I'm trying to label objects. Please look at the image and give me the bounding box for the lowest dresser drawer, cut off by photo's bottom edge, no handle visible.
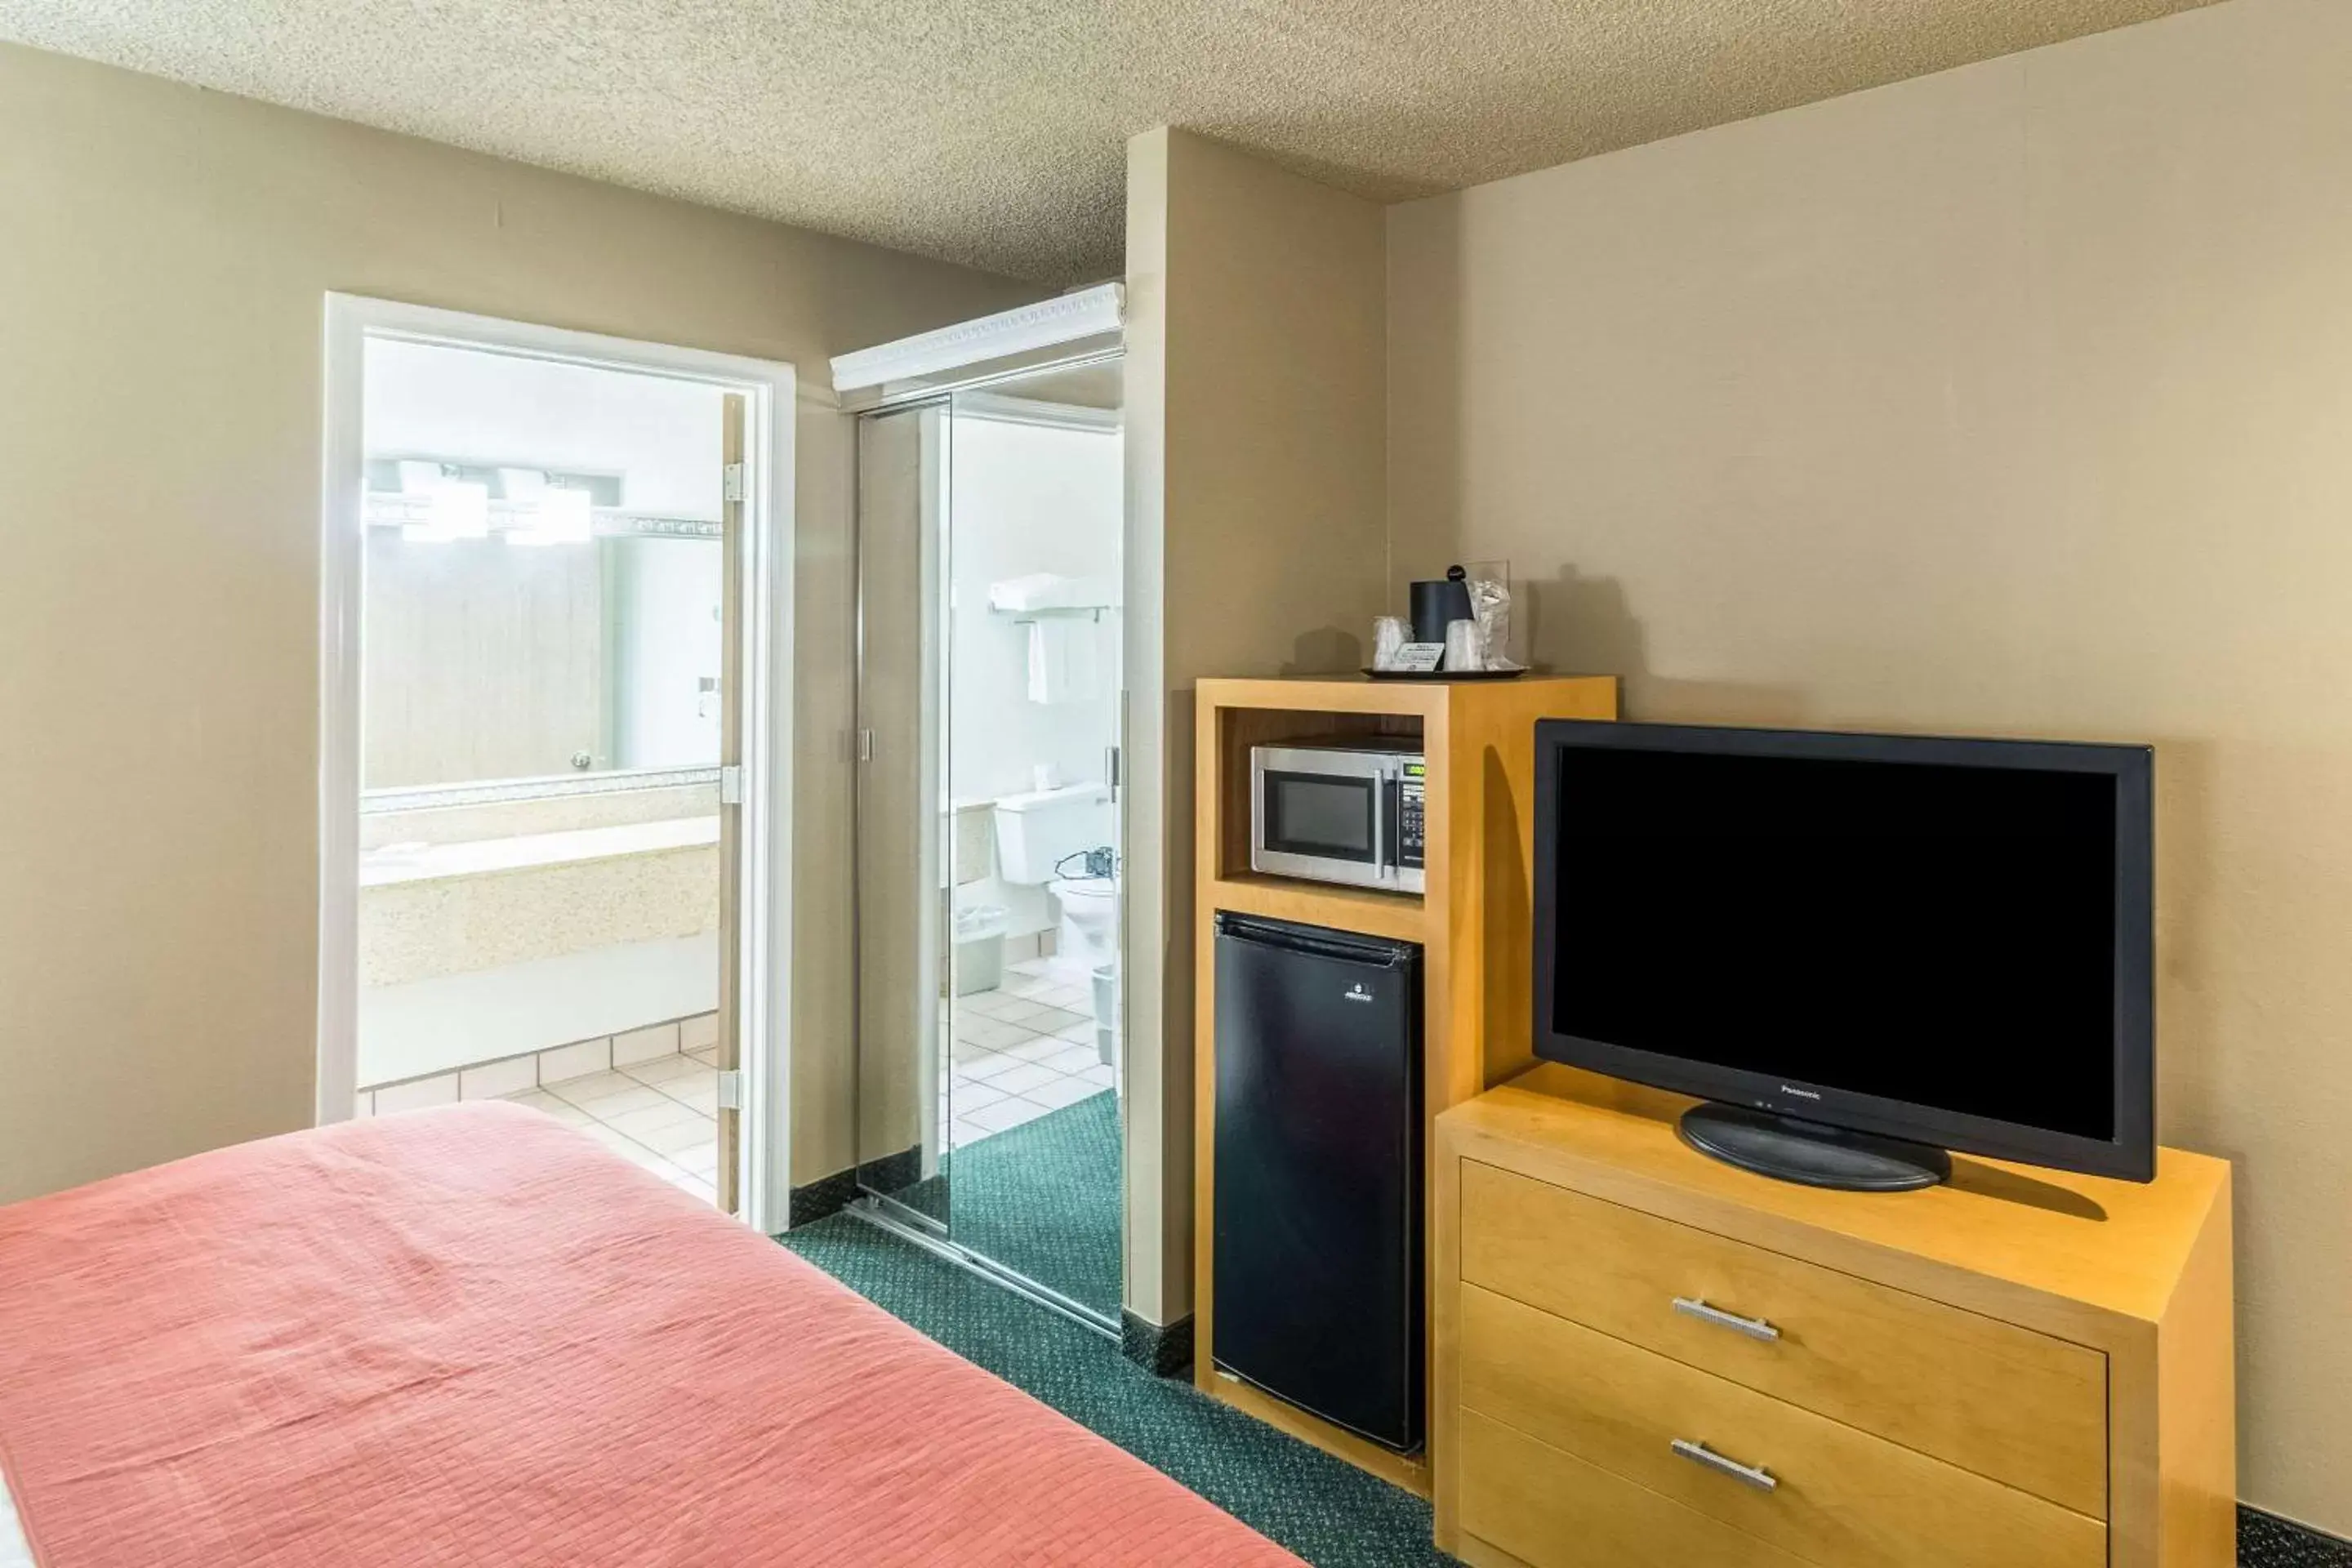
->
[1454,1410,1809,1568]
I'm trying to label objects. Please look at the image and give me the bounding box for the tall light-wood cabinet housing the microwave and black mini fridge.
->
[1192,675,1618,1498]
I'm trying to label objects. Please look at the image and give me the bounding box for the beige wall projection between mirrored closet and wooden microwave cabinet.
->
[1127,129,1385,1324]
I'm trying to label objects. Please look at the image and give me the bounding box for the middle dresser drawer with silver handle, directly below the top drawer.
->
[1459,1286,2107,1568]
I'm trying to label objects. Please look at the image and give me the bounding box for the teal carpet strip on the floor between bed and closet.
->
[781,1222,1454,1568]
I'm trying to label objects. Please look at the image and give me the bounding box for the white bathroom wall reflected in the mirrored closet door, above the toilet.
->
[948,412,1125,936]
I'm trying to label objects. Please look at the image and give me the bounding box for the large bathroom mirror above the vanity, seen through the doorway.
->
[360,328,724,797]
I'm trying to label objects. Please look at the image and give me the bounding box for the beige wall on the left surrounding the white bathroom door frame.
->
[0,47,1035,1199]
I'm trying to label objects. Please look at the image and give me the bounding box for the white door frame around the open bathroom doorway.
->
[318,294,795,1232]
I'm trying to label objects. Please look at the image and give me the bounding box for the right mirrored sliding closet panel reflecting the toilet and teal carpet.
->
[943,359,1125,1321]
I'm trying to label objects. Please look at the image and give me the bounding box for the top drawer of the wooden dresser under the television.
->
[1460,1159,2107,1519]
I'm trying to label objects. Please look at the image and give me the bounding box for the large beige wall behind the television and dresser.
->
[1390,0,2352,1530]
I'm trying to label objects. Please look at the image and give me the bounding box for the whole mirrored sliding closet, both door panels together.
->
[837,291,1125,1330]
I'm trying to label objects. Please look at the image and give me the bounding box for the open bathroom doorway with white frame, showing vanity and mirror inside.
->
[320,301,791,1227]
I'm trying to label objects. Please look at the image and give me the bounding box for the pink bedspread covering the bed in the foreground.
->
[0,1102,1298,1568]
